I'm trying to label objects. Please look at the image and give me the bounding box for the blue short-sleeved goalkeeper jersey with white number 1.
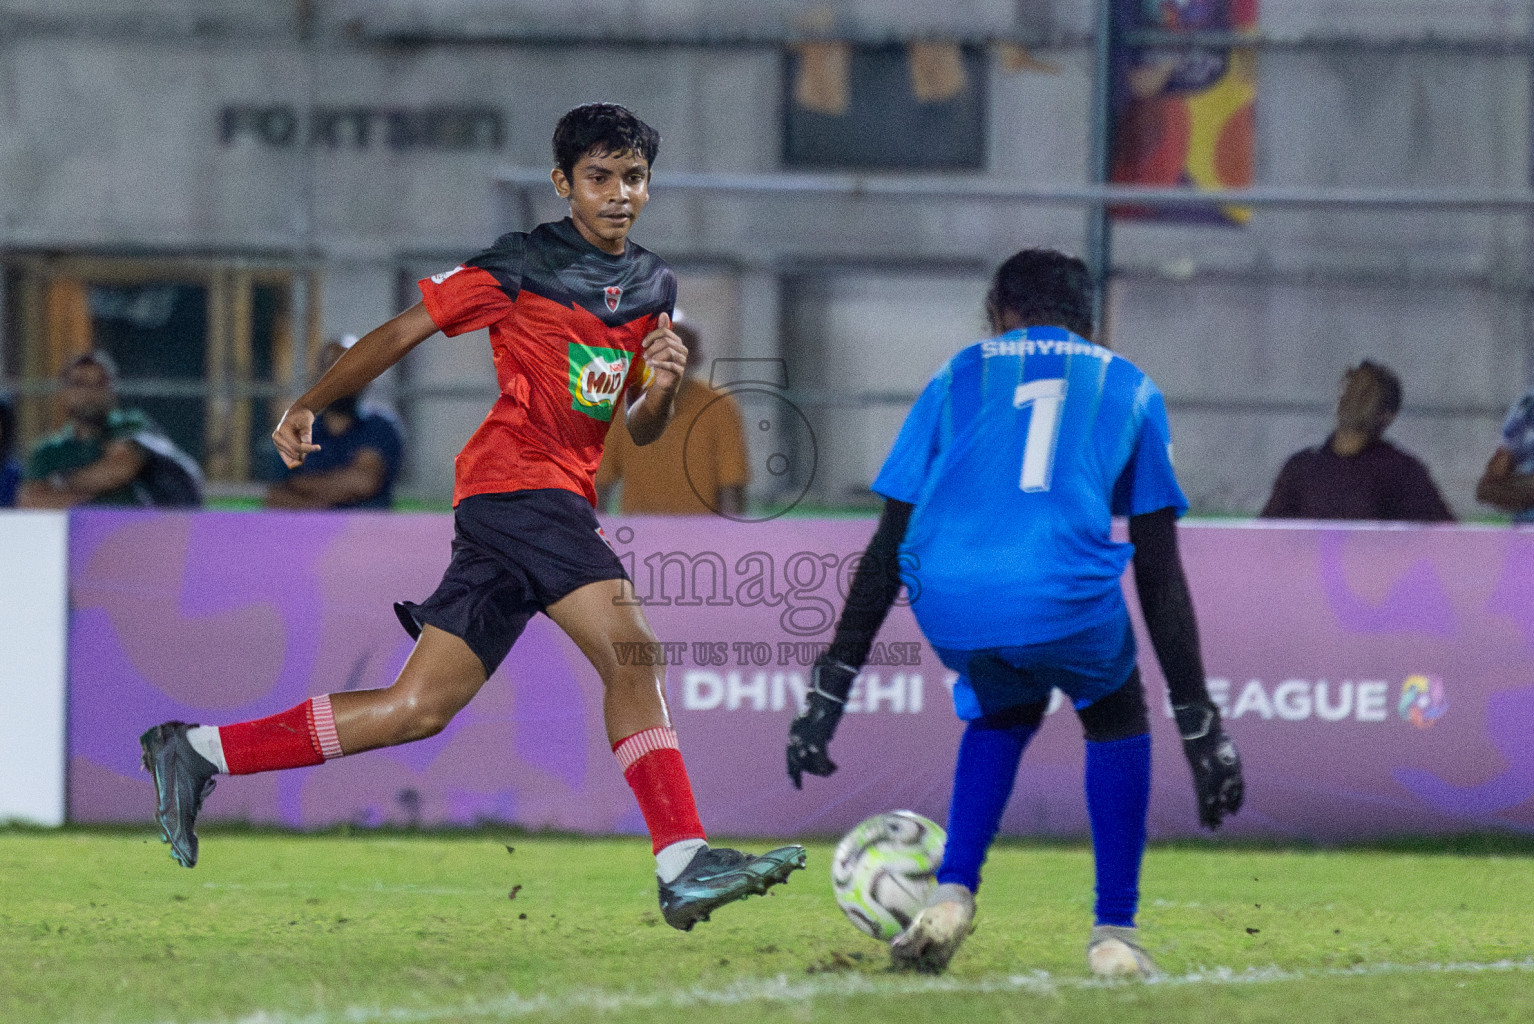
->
[873,327,1187,650]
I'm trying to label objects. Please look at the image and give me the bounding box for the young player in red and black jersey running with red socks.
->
[141,103,805,930]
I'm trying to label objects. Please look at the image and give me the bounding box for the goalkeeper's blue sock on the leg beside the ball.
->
[937,719,1035,892]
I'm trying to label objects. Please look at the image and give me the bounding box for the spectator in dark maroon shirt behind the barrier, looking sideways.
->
[1262,360,1454,523]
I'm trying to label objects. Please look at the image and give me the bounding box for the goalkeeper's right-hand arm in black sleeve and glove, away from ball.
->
[1129,509,1246,828]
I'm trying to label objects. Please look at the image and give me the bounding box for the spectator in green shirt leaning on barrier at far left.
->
[17,351,202,509]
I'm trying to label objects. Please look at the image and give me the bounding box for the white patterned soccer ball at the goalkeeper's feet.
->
[831,811,948,940]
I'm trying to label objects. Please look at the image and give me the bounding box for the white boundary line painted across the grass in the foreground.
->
[191,957,1534,1024]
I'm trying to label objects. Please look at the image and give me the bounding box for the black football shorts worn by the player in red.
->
[394,487,627,676]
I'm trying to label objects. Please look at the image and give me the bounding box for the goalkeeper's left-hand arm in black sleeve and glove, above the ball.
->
[788,498,913,789]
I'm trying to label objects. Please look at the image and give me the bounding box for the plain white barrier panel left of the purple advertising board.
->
[0,510,69,825]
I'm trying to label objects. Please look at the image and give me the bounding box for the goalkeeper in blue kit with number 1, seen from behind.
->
[788,250,1243,976]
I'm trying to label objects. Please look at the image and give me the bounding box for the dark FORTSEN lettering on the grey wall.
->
[218,103,506,152]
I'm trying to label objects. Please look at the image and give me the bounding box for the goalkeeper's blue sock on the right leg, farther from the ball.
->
[1086,733,1151,927]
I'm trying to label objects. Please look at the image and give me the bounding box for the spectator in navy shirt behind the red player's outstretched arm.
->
[265,334,405,509]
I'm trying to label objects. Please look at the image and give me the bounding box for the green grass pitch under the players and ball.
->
[0,828,1534,1024]
